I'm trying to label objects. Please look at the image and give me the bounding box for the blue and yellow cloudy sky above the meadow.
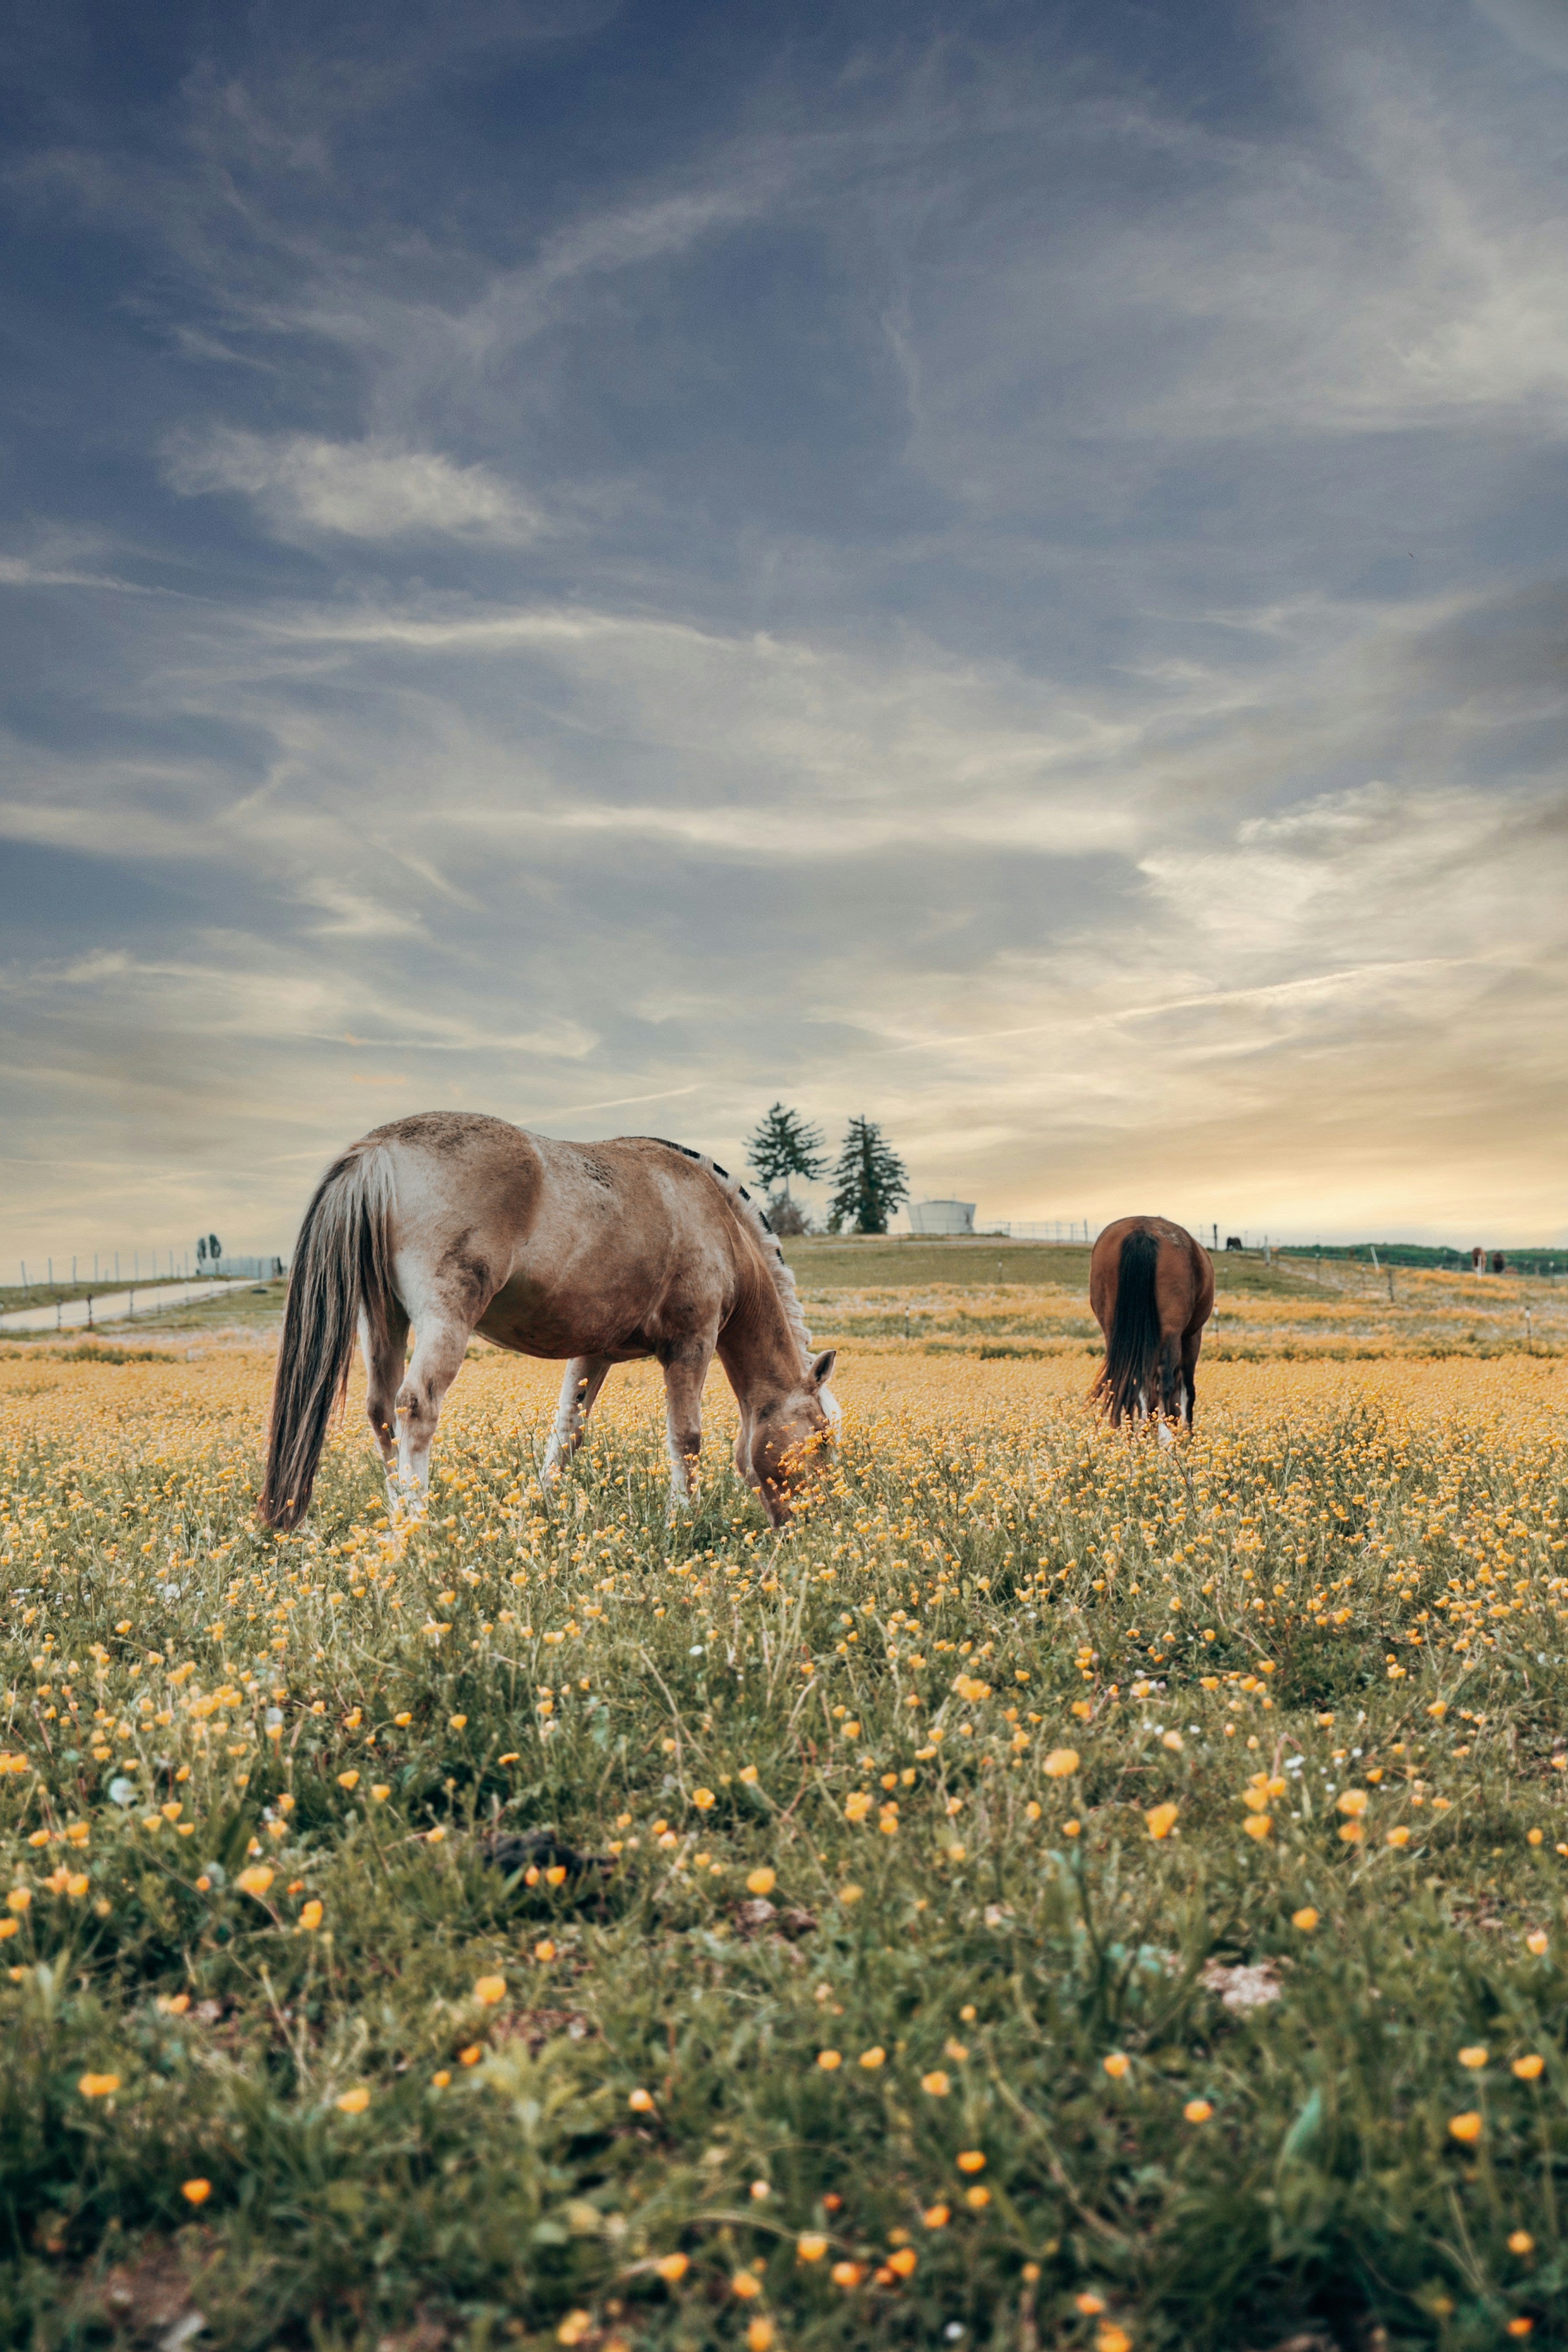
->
[0,0,1568,1280]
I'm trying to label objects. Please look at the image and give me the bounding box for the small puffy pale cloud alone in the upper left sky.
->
[164,426,543,546]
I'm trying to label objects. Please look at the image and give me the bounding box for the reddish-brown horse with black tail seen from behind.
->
[1088,1216,1213,1428]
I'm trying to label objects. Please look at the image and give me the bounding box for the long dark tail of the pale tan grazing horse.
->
[261,1146,393,1529]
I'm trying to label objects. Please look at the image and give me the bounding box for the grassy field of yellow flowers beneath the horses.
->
[0,1326,1568,2352]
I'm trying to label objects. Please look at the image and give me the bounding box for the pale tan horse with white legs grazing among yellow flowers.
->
[261,1110,839,1526]
